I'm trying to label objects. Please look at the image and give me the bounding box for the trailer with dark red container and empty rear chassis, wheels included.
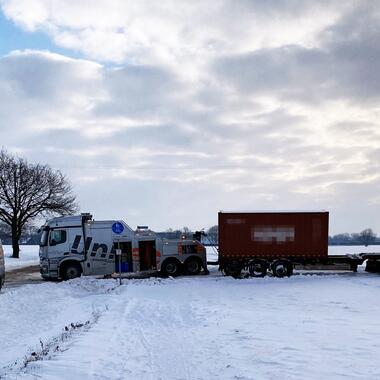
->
[218,211,380,277]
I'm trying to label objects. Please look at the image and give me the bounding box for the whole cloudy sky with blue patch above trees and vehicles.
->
[0,0,380,233]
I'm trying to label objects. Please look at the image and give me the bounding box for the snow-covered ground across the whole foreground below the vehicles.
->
[0,267,380,380]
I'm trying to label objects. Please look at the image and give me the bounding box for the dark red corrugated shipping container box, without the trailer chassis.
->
[219,211,329,258]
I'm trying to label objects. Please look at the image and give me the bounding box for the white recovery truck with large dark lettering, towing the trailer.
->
[40,214,208,280]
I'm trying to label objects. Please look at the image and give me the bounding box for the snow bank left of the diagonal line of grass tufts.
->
[0,278,116,379]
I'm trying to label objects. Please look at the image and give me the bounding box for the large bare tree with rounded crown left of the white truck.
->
[0,150,78,258]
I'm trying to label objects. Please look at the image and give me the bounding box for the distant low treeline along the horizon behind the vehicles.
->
[0,225,380,245]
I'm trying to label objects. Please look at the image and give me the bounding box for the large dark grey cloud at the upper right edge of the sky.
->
[214,2,380,102]
